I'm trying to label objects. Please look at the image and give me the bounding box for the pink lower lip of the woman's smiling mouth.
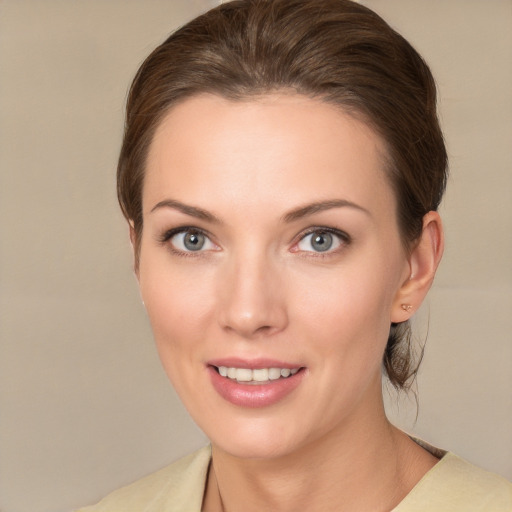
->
[208,366,304,408]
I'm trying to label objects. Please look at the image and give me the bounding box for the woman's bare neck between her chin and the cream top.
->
[205,384,437,512]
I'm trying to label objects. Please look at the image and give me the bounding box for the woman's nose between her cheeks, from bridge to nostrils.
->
[217,249,288,339]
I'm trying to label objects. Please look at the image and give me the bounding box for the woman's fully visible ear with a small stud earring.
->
[391,212,444,323]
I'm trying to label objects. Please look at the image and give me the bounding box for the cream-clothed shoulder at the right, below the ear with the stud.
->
[394,453,512,512]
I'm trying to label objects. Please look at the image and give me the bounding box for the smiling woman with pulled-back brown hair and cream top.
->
[78,0,512,512]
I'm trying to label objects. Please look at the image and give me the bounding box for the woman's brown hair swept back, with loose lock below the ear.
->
[117,0,447,389]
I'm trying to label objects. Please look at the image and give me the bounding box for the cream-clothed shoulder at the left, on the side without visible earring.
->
[77,446,211,512]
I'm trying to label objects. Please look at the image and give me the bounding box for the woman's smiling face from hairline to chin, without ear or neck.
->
[138,94,410,457]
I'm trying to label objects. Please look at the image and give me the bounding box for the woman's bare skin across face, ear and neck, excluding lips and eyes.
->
[132,93,443,511]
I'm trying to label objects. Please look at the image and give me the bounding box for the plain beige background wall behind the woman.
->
[0,0,512,512]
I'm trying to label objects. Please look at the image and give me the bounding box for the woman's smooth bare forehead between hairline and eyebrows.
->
[143,94,393,216]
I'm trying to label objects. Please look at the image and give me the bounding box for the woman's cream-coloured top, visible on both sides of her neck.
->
[78,442,512,512]
